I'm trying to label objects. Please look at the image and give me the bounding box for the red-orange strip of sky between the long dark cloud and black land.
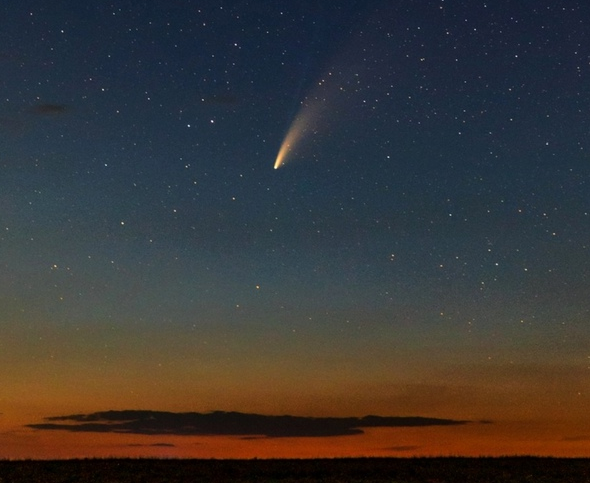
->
[0,422,590,459]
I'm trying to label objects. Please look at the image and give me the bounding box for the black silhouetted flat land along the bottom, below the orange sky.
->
[0,457,590,483]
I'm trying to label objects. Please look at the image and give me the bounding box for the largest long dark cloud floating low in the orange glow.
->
[27,410,467,437]
